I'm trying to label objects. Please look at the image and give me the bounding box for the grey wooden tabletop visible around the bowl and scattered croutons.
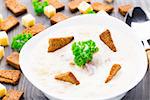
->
[0,0,150,100]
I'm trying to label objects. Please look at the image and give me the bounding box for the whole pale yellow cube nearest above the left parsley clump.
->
[22,14,35,27]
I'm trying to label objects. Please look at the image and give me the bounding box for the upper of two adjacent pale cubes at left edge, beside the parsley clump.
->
[0,31,9,46]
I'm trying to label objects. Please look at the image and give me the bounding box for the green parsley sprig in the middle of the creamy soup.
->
[72,40,99,68]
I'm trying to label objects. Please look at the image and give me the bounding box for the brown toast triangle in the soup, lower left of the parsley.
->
[55,72,80,85]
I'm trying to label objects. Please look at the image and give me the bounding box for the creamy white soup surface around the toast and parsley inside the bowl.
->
[25,26,143,100]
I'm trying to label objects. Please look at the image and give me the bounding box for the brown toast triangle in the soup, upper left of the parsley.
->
[48,36,74,52]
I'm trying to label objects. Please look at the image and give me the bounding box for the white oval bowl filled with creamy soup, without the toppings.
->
[20,14,147,100]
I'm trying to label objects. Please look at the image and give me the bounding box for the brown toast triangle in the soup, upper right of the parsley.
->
[99,29,117,52]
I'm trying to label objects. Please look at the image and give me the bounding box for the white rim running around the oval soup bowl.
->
[19,14,148,100]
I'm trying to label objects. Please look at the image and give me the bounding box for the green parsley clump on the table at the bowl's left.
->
[11,33,32,52]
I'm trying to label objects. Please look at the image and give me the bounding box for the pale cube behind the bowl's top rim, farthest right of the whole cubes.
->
[78,1,93,14]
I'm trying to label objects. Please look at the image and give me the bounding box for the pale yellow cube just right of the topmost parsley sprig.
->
[44,5,56,18]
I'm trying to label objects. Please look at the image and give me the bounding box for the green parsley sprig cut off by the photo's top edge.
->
[32,0,48,15]
